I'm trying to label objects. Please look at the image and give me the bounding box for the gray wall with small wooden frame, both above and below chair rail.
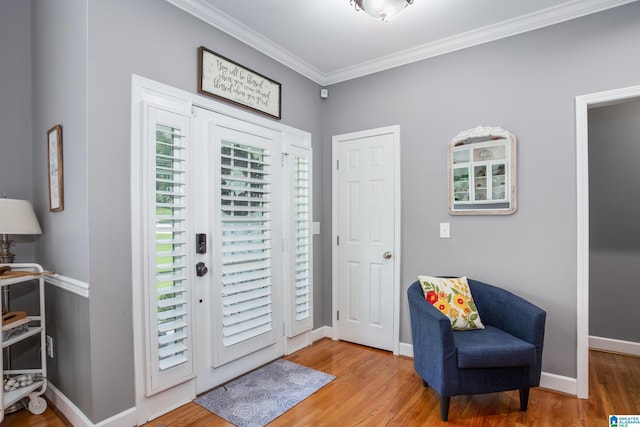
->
[30,0,94,418]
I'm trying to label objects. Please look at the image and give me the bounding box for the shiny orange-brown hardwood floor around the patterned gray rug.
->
[2,339,640,427]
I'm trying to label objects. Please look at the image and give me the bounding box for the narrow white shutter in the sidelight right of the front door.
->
[287,146,313,337]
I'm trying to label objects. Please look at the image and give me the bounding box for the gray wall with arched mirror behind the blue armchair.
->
[323,2,640,378]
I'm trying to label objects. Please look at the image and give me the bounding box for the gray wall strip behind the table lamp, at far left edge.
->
[0,0,35,262]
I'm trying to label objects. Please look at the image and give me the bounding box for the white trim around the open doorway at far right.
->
[576,86,640,399]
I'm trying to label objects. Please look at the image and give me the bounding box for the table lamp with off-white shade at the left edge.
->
[0,198,42,263]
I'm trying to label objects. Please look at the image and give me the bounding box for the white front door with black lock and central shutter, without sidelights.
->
[193,108,284,393]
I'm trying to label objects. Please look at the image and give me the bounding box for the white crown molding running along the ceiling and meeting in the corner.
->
[166,0,637,86]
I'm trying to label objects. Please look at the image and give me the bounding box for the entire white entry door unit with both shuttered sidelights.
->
[130,76,313,425]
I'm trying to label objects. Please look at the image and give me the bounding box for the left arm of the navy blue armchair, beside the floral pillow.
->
[407,281,458,397]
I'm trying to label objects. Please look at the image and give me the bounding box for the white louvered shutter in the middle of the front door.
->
[221,141,273,347]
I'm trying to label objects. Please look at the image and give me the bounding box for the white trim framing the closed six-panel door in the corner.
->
[331,125,401,355]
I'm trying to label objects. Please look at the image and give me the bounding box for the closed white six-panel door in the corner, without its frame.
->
[333,126,400,353]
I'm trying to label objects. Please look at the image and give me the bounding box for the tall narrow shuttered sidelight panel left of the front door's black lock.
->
[146,107,194,395]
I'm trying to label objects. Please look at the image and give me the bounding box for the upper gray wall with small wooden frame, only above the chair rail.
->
[31,0,89,282]
